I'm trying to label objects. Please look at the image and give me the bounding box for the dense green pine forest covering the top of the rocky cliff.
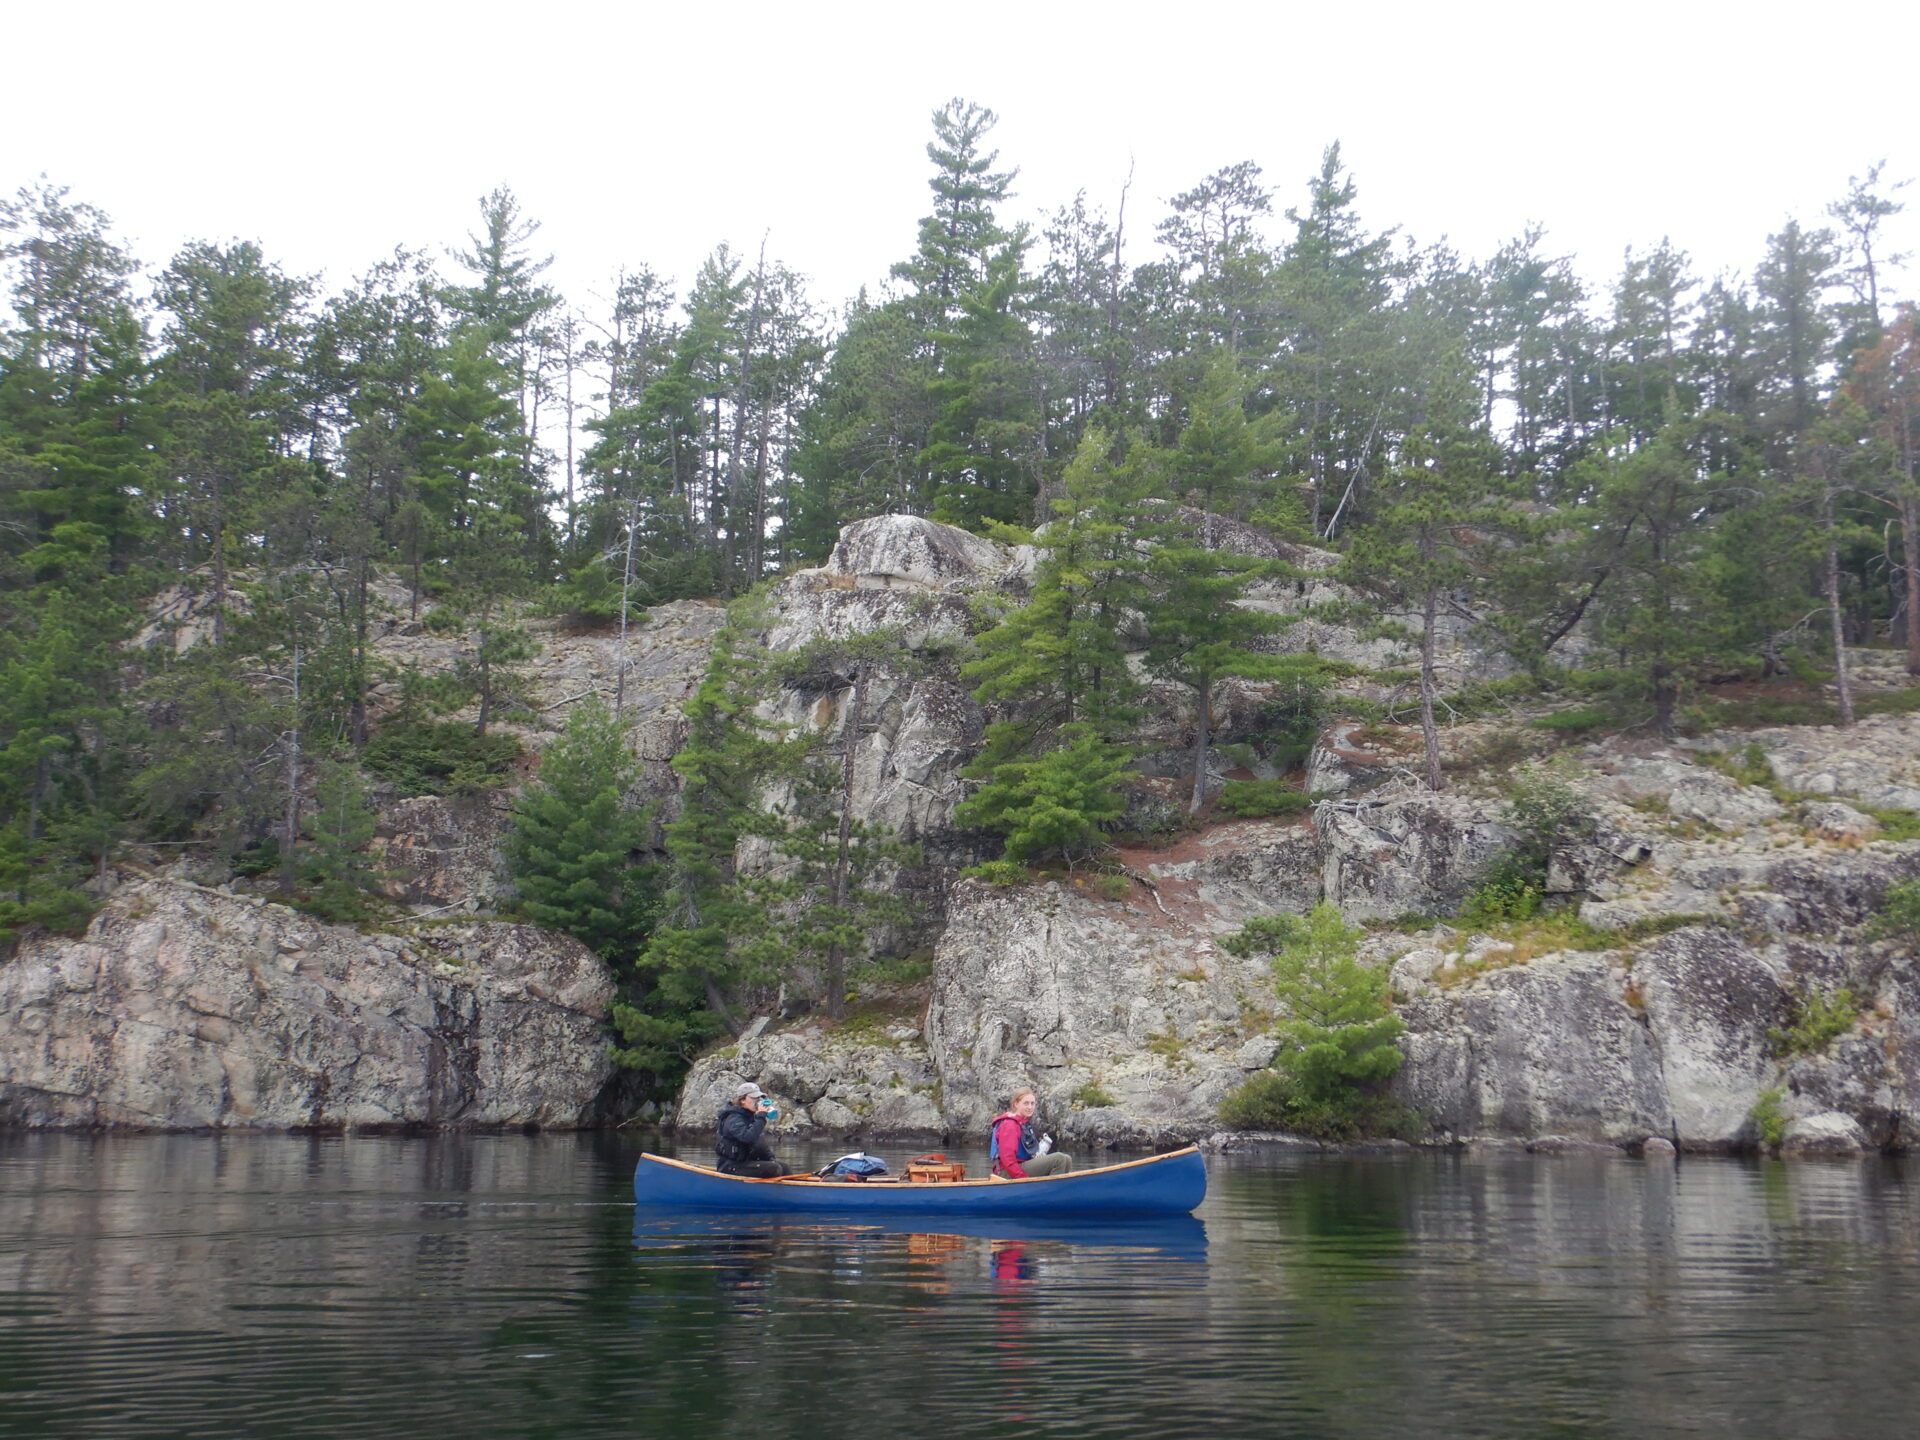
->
[0,100,1920,1052]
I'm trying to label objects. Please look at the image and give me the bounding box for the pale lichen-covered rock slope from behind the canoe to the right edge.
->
[682,537,1920,1152]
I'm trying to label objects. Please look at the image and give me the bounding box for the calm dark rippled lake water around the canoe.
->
[0,1135,1920,1440]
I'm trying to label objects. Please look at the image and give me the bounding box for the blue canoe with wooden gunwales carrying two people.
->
[634,1146,1206,1215]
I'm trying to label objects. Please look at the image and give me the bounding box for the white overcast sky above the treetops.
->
[0,0,1920,320]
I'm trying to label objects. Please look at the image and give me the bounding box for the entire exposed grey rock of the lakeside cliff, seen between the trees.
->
[15,516,1920,1152]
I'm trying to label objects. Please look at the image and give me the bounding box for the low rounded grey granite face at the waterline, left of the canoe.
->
[0,879,612,1129]
